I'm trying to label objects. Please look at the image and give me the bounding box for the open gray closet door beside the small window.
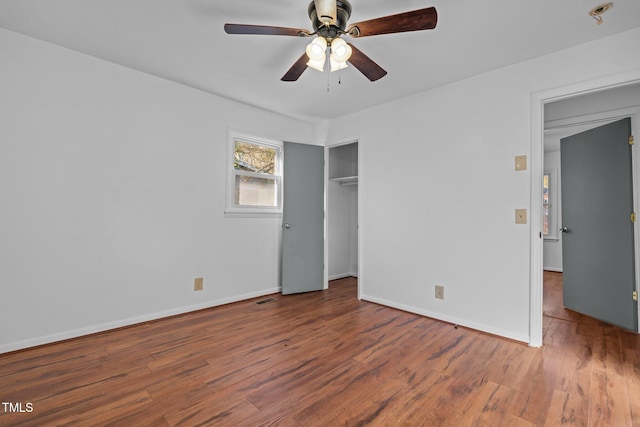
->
[282,142,324,295]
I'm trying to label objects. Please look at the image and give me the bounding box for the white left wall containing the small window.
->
[0,29,313,353]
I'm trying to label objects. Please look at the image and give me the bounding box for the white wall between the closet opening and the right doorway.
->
[328,29,640,342]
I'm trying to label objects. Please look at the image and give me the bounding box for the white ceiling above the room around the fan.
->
[0,0,640,121]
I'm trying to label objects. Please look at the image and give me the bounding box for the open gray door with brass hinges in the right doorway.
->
[560,119,638,331]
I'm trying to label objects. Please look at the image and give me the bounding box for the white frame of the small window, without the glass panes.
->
[225,130,284,217]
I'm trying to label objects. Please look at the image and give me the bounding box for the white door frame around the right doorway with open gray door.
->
[529,73,640,347]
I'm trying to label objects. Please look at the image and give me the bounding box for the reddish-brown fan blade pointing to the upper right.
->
[347,7,438,37]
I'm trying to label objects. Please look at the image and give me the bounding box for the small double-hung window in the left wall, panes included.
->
[226,132,282,215]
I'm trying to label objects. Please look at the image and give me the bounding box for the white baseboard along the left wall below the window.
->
[0,287,281,354]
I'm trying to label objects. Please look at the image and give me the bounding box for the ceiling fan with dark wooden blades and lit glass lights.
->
[224,0,438,82]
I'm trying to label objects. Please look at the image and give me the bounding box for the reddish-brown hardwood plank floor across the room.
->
[0,272,640,427]
